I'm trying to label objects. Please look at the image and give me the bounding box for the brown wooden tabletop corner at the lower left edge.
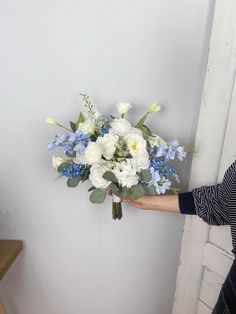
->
[0,240,23,280]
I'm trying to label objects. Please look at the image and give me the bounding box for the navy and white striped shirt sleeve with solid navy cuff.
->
[179,160,236,256]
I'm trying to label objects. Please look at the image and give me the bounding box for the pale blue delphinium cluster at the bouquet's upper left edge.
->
[48,130,90,155]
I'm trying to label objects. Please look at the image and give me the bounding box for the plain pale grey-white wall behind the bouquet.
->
[0,0,213,314]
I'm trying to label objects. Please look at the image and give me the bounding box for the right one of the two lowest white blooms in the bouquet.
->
[112,160,139,189]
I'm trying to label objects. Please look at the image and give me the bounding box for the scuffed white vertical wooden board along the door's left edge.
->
[172,0,236,314]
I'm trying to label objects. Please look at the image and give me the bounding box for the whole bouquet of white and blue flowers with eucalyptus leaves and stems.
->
[46,94,190,219]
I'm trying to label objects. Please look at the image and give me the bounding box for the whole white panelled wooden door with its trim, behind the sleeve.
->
[173,0,236,314]
